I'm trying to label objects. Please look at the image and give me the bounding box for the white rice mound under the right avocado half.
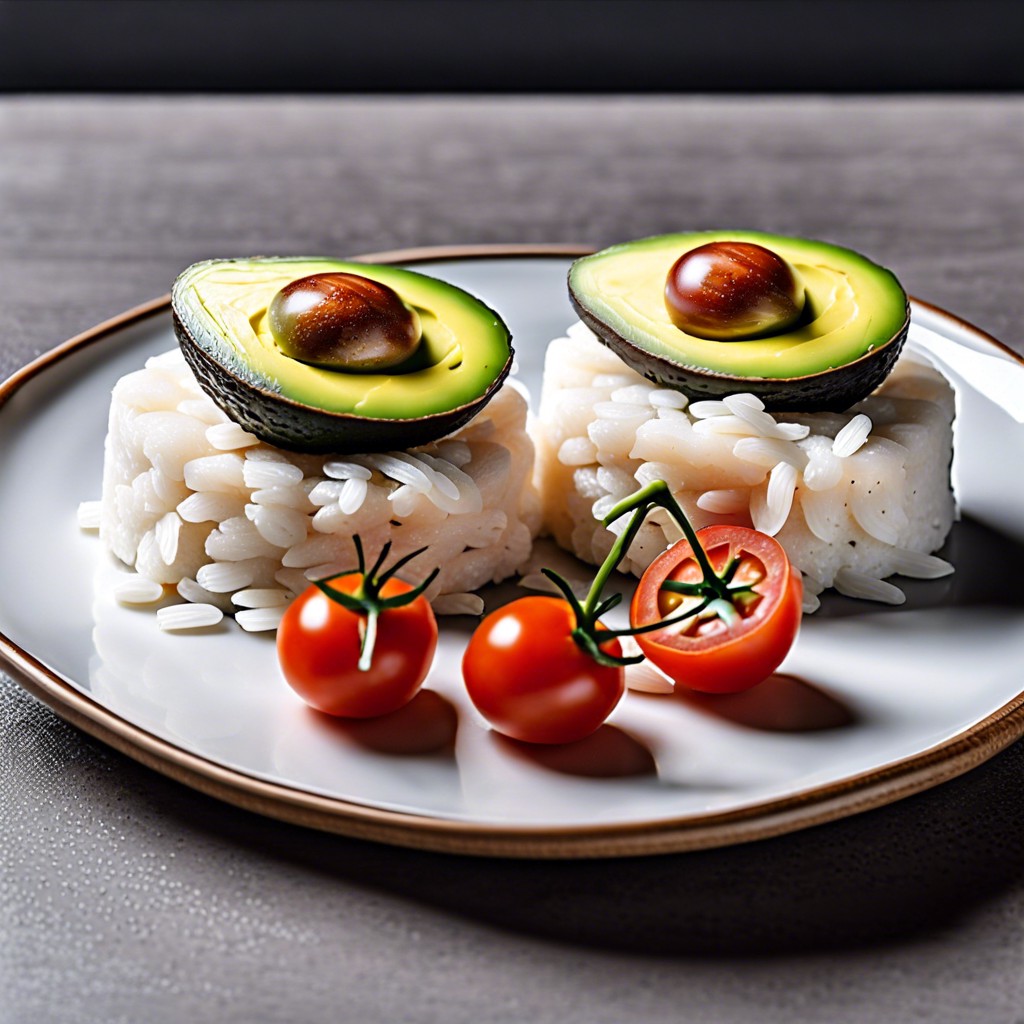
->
[535,324,955,610]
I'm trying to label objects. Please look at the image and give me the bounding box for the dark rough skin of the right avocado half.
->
[569,291,910,413]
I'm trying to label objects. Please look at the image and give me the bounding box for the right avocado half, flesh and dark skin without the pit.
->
[568,231,910,412]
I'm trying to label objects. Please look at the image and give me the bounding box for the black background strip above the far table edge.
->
[0,0,1024,93]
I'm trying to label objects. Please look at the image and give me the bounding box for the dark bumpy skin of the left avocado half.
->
[173,313,512,455]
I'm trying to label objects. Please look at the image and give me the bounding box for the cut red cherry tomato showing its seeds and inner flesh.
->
[630,526,803,693]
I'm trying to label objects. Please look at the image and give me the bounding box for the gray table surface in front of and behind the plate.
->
[0,96,1024,1024]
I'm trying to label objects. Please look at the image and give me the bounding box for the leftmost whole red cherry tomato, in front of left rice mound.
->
[278,572,437,718]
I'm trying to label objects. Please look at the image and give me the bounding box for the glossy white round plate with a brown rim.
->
[0,247,1024,856]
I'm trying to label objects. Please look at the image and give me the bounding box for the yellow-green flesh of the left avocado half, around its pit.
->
[172,258,511,420]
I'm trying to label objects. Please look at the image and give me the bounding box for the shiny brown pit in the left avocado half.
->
[267,273,423,373]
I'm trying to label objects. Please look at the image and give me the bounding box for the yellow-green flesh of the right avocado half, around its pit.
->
[569,231,907,380]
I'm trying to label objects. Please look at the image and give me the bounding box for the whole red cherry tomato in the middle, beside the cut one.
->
[462,597,626,743]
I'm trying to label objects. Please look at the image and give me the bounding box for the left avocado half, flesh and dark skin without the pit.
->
[171,257,512,455]
